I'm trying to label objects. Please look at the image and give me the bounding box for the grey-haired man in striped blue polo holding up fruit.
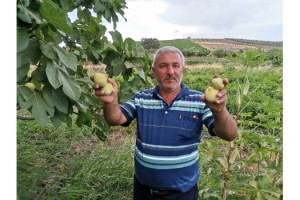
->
[91,46,237,200]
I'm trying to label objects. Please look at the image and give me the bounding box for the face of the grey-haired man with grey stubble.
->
[152,52,183,92]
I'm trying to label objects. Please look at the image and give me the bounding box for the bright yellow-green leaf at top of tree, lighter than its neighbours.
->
[40,0,72,33]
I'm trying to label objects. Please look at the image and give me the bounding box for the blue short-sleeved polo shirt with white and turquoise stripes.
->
[120,83,214,192]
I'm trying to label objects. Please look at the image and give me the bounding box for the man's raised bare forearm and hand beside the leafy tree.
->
[90,75,127,126]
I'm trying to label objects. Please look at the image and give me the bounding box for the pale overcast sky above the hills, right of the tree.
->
[103,0,283,41]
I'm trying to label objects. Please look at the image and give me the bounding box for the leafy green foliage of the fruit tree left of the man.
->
[17,0,152,138]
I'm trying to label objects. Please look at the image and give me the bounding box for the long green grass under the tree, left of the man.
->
[17,116,133,200]
